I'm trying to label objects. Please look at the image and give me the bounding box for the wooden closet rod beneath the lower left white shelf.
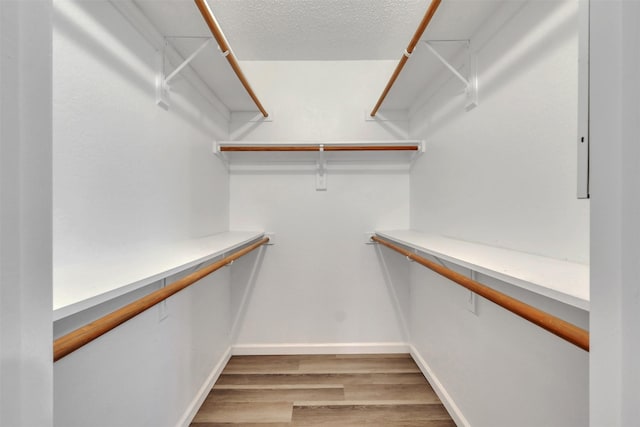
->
[53,237,269,362]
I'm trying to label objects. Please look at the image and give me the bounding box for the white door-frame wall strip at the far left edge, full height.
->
[0,1,53,427]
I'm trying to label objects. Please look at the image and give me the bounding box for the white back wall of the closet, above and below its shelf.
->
[230,61,409,351]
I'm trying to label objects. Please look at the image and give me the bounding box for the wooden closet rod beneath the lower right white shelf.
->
[371,236,589,351]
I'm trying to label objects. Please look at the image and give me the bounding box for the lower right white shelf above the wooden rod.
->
[376,230,589,311]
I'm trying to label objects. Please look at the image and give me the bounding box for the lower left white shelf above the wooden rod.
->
[53,231,264,321]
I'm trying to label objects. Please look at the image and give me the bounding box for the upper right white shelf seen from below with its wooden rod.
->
[372,0,524,115]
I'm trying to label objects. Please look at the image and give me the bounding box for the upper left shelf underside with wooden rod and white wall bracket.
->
[112,0,269,121]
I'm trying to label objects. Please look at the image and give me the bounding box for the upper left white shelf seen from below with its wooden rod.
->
[119,0,266,118]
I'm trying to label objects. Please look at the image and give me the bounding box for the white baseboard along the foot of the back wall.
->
[231,342,409,356]
